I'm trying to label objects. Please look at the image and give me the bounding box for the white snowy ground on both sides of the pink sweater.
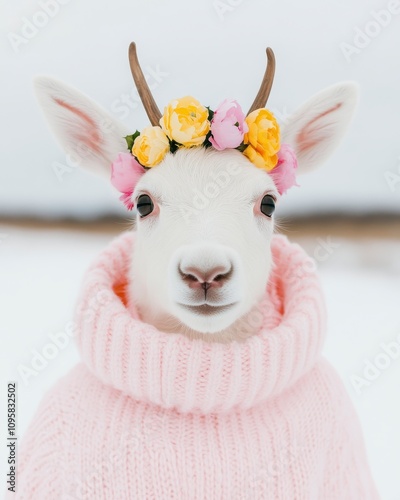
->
[0,225,400,500]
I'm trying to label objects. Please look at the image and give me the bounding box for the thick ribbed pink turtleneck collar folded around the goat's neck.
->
[77,233,325,413]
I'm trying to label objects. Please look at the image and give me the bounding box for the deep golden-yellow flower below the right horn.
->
[243,108,280,172]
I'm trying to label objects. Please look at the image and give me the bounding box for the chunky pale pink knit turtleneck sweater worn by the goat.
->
[10,234,378,500]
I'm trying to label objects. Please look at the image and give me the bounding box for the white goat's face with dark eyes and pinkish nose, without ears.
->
[131,148,279,333]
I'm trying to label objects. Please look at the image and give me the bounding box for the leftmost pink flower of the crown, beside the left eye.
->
[111,153,146,210]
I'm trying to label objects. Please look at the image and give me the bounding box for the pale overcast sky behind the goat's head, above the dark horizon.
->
[0,0,400,217]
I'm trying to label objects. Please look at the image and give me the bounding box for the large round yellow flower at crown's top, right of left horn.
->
[160,96,210,147]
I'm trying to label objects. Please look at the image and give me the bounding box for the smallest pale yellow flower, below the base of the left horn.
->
[132,126,170,167]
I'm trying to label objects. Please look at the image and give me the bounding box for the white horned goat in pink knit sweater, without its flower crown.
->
[9,45,378,500]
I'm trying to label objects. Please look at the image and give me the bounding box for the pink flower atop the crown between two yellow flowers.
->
[210,99,249,151]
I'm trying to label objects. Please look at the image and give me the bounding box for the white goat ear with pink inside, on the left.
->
[34,76,128,176]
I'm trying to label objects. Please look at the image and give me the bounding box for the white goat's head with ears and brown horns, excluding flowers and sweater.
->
[36,45,357,342]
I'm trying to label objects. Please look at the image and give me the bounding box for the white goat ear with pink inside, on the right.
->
[282,82,358,174]
